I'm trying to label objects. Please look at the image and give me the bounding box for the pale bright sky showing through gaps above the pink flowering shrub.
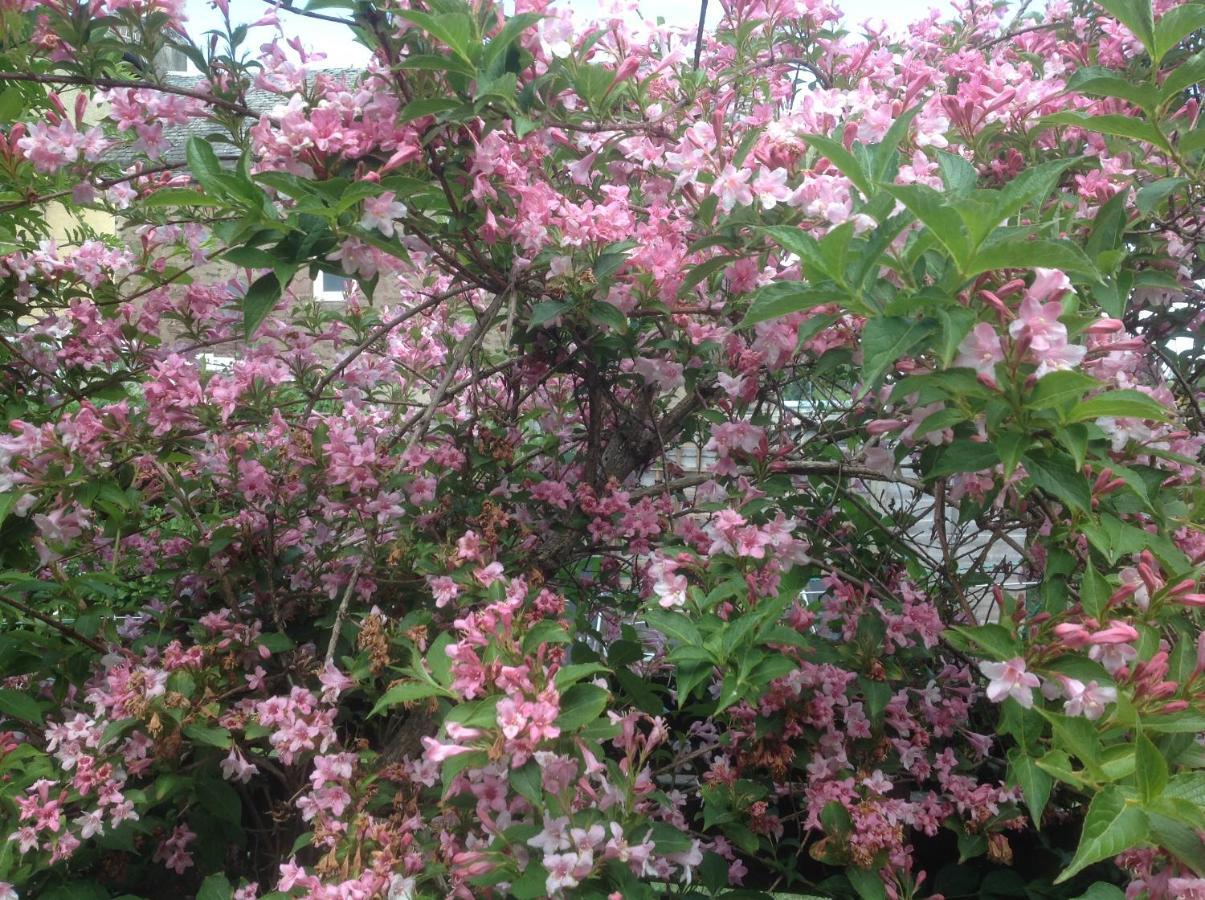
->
[186,0,948,66]
